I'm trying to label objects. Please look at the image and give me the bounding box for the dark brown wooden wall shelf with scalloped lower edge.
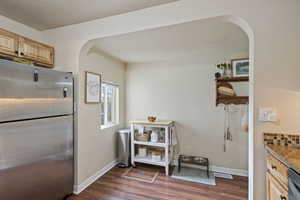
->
[216,77,249,105]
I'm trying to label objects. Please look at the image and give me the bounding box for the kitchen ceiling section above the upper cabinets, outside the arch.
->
[0,0,176,30]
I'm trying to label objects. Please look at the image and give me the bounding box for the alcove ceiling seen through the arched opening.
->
[93,20,249,63]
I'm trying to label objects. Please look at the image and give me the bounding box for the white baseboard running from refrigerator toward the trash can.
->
[73,161,118,194]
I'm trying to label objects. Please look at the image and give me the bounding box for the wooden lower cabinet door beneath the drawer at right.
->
[267,172,288,200]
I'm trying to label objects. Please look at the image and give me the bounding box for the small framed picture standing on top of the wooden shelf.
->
[231,58,249,77]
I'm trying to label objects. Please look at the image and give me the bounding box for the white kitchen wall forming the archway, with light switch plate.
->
[44,0,300,200]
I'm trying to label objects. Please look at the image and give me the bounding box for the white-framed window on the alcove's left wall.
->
[100,82,119,129]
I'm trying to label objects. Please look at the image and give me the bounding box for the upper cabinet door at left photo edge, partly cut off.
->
[0,29,18,56]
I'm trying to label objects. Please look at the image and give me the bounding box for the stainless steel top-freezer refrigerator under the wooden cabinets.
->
[0,60,74,200]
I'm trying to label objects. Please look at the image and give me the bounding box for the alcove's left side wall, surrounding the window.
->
[75,42,125,185]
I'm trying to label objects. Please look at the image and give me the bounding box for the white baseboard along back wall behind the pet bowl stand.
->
[174,161,248,177]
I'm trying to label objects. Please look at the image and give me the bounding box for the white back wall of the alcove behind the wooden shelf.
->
[126,59,249,171]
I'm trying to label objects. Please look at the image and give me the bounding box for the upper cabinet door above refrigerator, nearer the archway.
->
[20,37,54,66]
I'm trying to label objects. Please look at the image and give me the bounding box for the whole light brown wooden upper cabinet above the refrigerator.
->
[0,29,54,67]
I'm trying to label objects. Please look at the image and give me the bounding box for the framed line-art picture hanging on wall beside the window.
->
[85,72,101,103]
